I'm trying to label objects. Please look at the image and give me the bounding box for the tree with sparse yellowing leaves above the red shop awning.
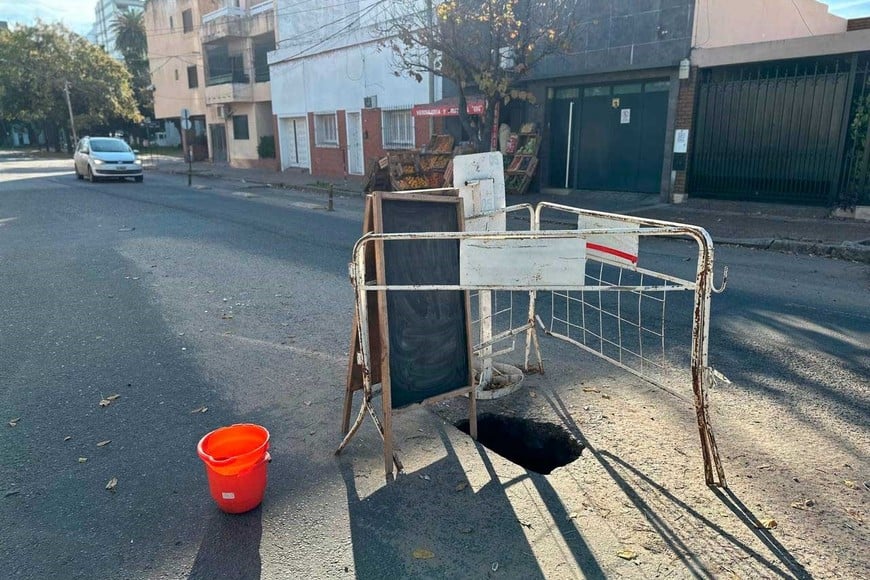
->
[380,0,578,151]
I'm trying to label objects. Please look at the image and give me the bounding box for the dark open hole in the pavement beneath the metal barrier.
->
[456,413,583,475]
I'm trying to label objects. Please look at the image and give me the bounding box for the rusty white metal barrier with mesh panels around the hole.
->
[339,203,725,486]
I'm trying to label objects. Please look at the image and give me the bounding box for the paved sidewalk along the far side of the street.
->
[145,156,870,264]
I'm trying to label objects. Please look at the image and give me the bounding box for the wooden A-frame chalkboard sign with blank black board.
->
[336,190,477,478]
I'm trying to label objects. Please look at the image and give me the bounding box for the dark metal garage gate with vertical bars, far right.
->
[689,53,870,206]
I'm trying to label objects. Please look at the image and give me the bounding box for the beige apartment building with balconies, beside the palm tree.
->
[146,0,275,167]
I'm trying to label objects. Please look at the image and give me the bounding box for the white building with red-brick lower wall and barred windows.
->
[269,0,441,176]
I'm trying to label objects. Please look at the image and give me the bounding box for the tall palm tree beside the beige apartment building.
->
[112,8,154,125]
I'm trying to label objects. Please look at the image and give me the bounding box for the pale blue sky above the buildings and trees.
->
[0,0,870,35]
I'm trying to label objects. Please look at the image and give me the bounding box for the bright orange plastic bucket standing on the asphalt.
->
[196,423,272,514]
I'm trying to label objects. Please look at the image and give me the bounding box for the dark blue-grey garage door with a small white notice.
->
[549,80,670,193]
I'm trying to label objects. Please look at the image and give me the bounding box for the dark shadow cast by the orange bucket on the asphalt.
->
[188,506,263,580]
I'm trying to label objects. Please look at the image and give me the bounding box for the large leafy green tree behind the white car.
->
[0,22,141,150]
